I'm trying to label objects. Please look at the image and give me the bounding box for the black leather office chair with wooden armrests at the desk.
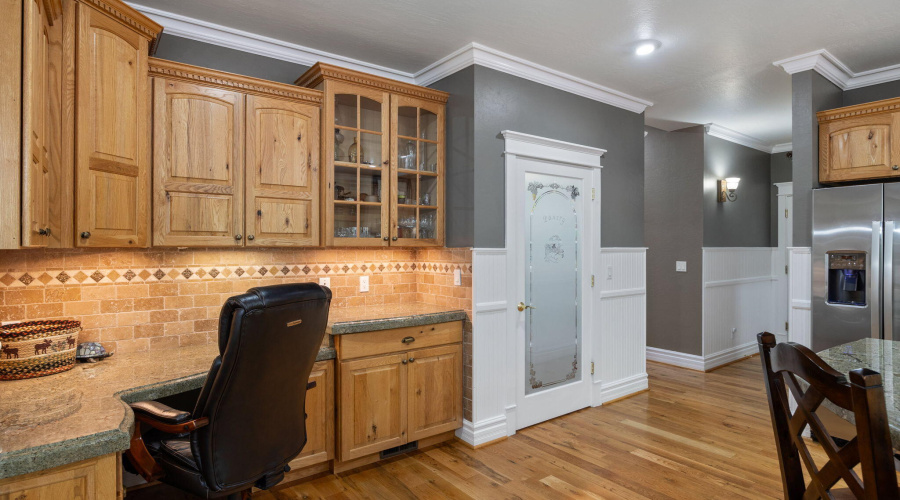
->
[126,283,331,498]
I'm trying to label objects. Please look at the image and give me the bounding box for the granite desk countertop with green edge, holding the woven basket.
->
[0,342,335,479]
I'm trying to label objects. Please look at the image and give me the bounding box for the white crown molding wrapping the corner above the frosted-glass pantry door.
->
[415,42,653,113]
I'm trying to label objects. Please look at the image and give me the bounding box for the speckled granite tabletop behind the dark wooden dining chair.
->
[817,339,900,449]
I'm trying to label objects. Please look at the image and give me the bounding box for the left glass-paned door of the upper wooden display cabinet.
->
[322,82,391,246]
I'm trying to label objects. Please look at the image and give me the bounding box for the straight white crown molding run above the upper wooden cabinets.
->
[128,3,414,83]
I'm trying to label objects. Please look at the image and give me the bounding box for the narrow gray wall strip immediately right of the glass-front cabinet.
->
[431,66,475,247]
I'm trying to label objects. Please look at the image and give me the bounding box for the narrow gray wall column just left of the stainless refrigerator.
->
[791,70,843,247]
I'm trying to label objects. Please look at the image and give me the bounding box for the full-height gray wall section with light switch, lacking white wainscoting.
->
[644,126,705,355]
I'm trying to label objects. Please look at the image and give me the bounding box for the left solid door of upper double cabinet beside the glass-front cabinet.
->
[153,78,244,246]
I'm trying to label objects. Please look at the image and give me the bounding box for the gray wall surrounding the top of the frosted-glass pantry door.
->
[474,66,644,248]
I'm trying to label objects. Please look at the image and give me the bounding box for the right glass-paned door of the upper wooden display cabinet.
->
[390,95,444,246]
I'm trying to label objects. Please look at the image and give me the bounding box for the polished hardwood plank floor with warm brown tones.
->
[254,357,800,500]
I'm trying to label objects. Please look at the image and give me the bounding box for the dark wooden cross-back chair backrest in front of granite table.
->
[757,332,900,500]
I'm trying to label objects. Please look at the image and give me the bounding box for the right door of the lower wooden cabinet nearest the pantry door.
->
[408,344,463,441]
